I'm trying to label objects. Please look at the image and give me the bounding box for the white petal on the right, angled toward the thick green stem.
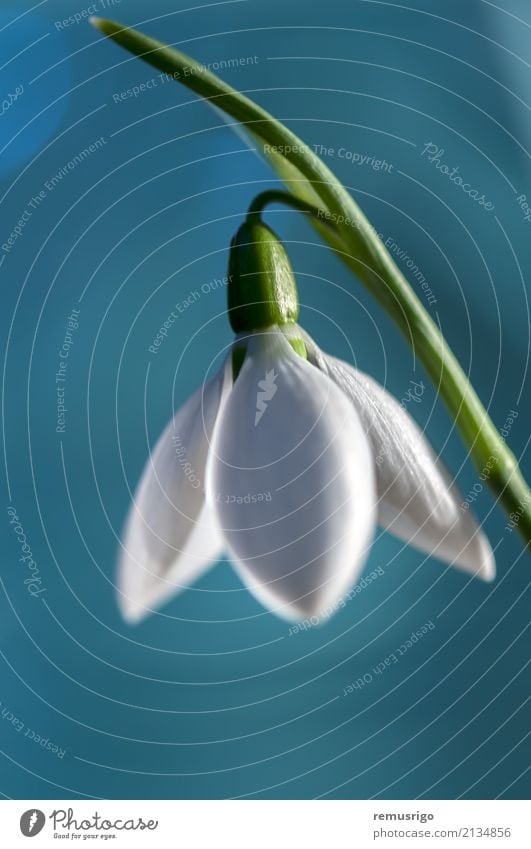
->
[305,336,495,581]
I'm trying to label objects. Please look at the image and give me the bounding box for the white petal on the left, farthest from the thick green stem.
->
[118,358,230,622]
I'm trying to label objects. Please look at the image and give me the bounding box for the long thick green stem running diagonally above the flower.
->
[92,18,531,544]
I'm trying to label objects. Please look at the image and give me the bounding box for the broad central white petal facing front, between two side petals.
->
[207,328,376,619]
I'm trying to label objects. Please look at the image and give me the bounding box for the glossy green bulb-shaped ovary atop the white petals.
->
[227,216,299,333]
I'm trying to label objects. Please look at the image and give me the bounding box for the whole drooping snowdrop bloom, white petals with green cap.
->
[118,221,495,621]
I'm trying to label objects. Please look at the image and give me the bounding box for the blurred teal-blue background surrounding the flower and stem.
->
[0,0,531,799]
